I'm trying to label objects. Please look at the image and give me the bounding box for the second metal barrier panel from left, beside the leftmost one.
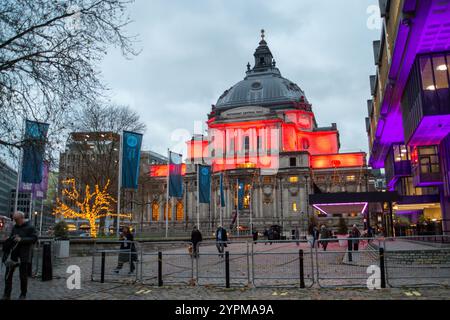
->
[139,242,194,286]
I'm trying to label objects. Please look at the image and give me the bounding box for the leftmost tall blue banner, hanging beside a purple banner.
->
[22,120,49,183]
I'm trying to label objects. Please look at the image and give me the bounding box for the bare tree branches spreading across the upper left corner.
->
[0,0,137,165]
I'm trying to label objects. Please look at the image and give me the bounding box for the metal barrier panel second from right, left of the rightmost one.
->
[315,238,380,288]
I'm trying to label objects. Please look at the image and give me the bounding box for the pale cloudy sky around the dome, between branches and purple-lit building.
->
[101,0,380,158]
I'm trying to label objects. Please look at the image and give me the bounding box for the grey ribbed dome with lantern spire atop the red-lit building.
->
[215,33,307,109]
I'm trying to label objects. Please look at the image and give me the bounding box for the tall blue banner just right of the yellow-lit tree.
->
[122,131,142,189]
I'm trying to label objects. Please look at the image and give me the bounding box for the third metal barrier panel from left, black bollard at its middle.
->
[196,241,250,288]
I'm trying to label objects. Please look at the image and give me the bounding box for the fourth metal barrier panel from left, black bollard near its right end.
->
[251,240,314,288]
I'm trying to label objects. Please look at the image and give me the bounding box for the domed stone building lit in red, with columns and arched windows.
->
[142,32,369,238]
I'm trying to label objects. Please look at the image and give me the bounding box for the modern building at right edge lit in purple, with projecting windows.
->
[366,0,450,235]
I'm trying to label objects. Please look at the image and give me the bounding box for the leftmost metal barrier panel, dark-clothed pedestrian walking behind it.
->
[91,241,140,283]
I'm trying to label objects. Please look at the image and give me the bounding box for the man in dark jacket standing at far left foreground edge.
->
[2,211,38,300]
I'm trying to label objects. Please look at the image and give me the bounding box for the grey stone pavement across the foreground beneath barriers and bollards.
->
[0,243,450,300]
